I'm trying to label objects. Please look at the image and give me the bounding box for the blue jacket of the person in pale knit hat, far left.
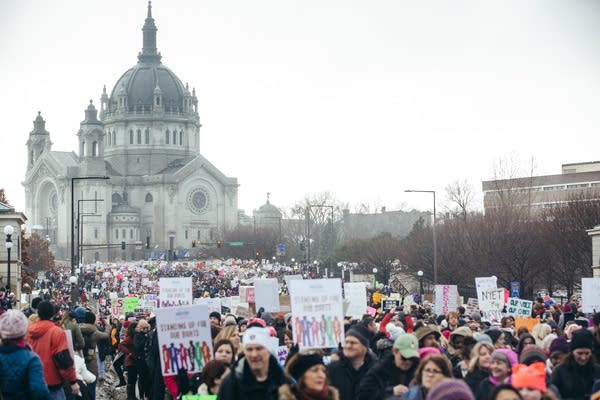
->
[0,342,50,400]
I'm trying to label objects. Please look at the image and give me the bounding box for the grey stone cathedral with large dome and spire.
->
[23,3,238,263]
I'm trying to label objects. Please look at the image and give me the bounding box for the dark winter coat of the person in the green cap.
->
[356,354,418,400]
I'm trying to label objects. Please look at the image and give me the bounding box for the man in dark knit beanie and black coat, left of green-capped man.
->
[327,325,377,400]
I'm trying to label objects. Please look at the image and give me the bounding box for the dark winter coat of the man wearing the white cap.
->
[218,355,290,400]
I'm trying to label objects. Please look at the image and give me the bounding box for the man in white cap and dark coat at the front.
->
[218,326,288,400]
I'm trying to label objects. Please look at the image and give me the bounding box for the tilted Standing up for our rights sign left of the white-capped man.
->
[155,304,213,376]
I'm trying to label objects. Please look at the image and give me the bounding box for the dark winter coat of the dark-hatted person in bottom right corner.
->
[551,356,600,400]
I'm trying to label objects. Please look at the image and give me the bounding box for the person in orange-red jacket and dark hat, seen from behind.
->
[26,301,80,400]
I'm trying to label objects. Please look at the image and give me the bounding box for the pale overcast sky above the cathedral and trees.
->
[0,0,600,219]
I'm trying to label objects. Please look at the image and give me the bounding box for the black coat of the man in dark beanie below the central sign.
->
[327,352,377,400]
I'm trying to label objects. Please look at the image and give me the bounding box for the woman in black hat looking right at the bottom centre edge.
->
[279,352,339,400]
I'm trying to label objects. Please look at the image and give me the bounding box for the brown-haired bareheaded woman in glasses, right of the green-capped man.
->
[401,354,452,400]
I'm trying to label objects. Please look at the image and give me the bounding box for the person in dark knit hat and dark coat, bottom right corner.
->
[551,329,600,399]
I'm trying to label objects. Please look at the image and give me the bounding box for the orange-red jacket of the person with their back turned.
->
[25,321,77,386]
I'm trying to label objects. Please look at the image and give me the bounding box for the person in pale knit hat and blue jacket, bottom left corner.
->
[0,310,50,400]
